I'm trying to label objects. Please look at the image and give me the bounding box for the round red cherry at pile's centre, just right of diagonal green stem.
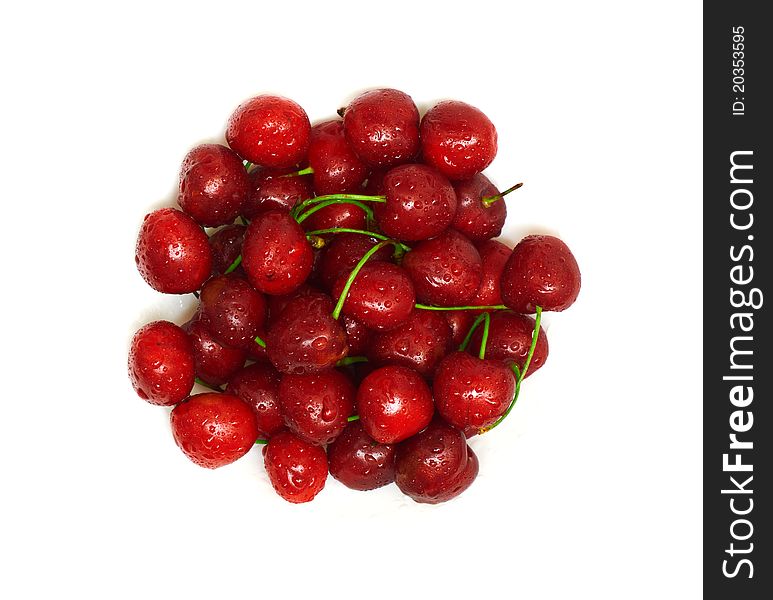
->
[333,261,416,331]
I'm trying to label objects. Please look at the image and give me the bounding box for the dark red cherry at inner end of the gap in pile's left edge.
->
[199,275,266,350]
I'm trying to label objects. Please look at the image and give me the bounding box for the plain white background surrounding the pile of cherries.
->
[0,0,702,600]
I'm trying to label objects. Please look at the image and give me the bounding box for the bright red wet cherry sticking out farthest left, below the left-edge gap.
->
[129,321,194,406]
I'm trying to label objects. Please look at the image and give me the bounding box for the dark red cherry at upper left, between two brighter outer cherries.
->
[177,144,247,227]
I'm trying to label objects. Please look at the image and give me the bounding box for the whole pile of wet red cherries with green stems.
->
[129,89,580,503]
